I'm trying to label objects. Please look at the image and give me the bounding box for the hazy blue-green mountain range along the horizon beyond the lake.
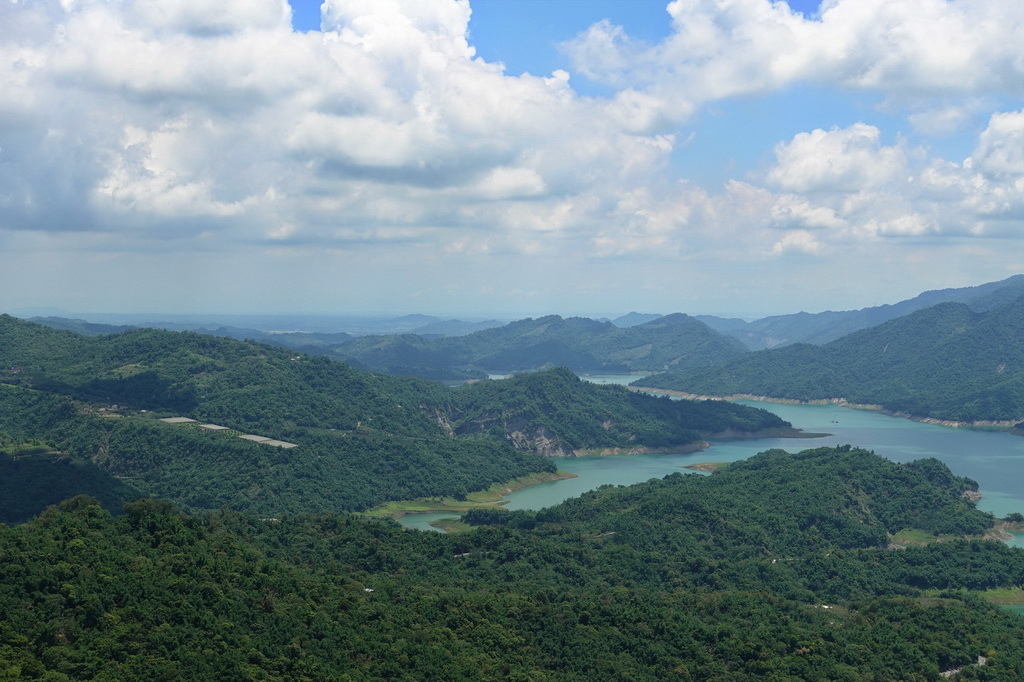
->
[18,274,1024,423]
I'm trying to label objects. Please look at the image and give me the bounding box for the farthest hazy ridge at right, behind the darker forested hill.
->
[700,274,1024,350]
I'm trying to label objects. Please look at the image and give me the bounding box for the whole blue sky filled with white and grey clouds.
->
[0,0,1024,316]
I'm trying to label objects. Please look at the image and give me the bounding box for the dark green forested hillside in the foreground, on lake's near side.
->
[0,447,1024,681]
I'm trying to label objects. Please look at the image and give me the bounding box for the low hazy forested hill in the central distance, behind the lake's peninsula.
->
[334,313,745,376]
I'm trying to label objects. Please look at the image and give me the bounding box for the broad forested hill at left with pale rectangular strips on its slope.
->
[0,315,782,520]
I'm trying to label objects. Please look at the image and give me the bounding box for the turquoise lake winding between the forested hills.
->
[401,399,1024,532]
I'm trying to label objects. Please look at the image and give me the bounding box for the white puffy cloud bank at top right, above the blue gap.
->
[565,0,1024,107]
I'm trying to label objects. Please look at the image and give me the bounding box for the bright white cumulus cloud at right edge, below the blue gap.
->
[764,112,1024,246]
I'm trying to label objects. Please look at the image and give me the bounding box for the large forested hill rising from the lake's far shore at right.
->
[636,297,1024,422]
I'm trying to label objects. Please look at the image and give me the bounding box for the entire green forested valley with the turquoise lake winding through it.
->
[0,274,1024,680]
